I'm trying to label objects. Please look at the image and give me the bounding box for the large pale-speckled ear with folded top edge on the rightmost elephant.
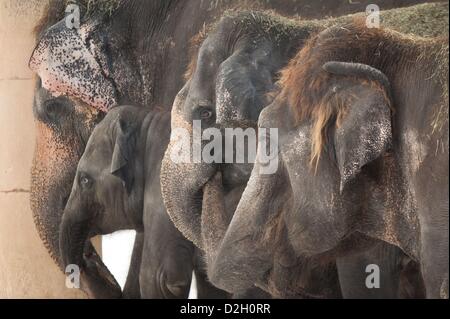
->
[324,62,392,192]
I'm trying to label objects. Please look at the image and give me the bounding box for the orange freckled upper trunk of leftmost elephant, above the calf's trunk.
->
[31,122,81,266]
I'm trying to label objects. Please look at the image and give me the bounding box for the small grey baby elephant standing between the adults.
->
[59,106,226,298]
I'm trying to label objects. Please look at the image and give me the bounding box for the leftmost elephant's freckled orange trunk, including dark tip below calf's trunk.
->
[30,114,120,298]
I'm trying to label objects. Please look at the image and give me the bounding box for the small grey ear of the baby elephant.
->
[111,118,137,194]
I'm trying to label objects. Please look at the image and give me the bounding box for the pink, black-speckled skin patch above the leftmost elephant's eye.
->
[29,20,117,112]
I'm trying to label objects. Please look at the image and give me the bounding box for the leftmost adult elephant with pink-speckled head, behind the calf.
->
[30,0,326,297]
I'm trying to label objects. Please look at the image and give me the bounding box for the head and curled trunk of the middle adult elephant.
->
[161,12,306,252]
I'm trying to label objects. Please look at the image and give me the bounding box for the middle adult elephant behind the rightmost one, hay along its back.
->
[162,4,448,296]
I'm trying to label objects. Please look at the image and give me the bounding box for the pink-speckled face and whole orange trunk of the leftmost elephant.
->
[29,11,124,297]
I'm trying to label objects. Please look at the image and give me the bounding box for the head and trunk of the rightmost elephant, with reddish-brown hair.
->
[210,27,424,291]
